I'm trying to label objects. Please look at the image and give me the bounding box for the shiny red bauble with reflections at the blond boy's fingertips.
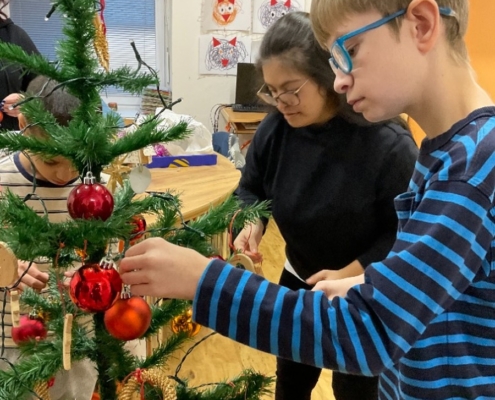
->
[69,264,122,312]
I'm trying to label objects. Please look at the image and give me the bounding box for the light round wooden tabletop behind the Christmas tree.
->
[147,154,241,221]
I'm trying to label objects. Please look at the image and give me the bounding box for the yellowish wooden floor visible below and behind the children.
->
[163,222,334,400]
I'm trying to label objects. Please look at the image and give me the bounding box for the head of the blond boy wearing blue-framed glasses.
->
[311,0,473,124]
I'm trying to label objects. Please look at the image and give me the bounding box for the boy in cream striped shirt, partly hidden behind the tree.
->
[0,76,96,400]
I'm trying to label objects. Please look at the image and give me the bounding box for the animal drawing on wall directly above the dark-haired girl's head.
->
[253,0,304,33]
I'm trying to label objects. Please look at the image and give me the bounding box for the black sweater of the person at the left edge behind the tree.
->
[0,19,39,130]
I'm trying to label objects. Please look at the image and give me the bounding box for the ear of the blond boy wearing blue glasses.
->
[406,0,441,53]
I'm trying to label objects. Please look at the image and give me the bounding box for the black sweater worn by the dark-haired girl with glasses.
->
[239,112,418,279]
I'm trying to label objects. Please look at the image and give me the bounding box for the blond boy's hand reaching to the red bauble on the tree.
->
[119,238,210,300]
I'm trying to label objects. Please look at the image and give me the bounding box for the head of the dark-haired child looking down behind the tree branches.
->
[19,76,79,186]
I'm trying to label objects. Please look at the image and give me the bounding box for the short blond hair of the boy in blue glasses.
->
[310,0,469,61]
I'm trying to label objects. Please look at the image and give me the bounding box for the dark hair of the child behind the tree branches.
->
[25,76,80,126]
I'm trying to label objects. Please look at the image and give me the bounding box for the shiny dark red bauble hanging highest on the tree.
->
[67,172,113,221]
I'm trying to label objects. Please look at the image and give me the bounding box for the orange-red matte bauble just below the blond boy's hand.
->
[104,297,151,340]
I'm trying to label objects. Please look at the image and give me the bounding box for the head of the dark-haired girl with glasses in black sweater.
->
[257,12,372,126]
